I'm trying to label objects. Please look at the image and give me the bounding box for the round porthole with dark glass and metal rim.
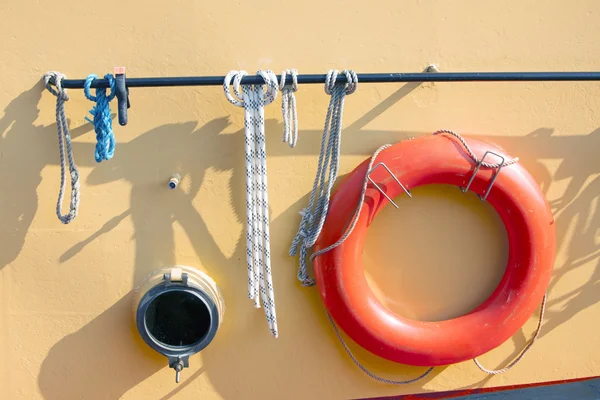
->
[133,266,225,383]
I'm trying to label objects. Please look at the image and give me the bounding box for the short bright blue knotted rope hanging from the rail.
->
[83,74,115,162]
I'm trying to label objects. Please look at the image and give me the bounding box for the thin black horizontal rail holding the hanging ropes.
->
[57,72,600,89]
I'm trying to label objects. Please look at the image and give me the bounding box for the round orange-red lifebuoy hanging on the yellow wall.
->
[313,135,556,366]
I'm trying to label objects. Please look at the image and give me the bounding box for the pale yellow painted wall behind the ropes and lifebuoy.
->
[0,0,600,400]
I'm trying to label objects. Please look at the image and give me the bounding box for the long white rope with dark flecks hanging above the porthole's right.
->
[223,71,278,338]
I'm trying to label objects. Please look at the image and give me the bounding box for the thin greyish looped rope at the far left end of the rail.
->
[44,71,79,224]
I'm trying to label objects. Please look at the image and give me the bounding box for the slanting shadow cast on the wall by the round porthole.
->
[38,292,164,400]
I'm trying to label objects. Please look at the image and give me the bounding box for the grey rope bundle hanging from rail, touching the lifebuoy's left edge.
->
[289,70,358,286]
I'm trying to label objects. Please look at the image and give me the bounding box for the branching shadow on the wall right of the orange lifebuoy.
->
[480,128,600,337]
